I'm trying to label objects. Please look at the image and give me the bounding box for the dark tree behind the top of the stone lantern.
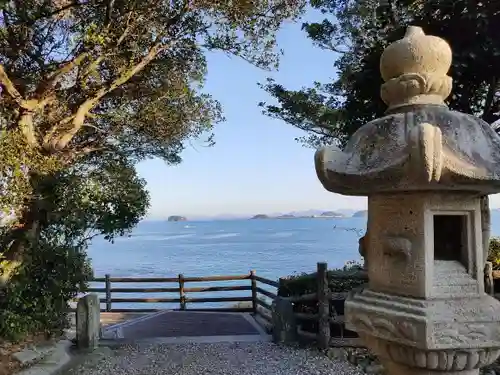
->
[261,0,500,147]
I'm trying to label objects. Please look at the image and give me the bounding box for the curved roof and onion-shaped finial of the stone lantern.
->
[315,29,500,195]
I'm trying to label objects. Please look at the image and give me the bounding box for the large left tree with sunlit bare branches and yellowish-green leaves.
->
[0,0,303,270]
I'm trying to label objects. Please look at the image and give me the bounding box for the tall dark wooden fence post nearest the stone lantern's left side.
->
[316,263,330,349]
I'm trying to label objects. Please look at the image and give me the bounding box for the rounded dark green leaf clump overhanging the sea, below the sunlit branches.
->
[45,158,149,244]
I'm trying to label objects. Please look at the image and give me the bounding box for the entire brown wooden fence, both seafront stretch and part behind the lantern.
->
[71,263,500,348]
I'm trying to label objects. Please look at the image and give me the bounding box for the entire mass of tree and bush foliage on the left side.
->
[0,0,304,337]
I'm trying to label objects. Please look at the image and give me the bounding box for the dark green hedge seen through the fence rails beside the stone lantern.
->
[278,262,366,337]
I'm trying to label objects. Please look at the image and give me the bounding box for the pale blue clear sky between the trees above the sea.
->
[137,8,500,219]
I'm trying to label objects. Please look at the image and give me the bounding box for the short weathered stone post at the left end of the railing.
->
[76,294,101,350]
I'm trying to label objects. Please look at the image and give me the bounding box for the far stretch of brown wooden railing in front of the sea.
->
[77,271,278,314]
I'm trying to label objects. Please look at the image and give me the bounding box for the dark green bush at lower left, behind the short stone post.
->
[0,241,92,341]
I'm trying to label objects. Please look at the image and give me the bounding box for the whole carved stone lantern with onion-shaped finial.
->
[315,27,500,375]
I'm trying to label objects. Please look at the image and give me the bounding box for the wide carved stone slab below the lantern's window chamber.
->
[346,289,500,350]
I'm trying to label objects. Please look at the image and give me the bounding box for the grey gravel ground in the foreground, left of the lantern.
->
[64,342,361,375]
